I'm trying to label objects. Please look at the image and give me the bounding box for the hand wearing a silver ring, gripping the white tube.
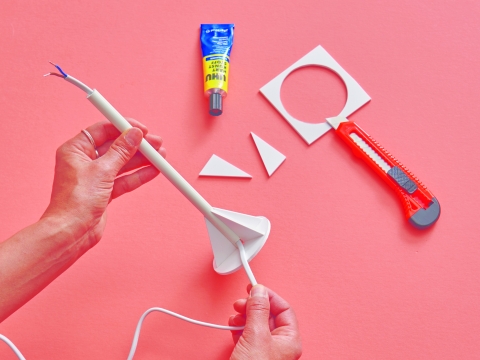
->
[42,119,166,252]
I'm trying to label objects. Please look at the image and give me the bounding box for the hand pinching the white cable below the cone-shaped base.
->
[228,285,302,360]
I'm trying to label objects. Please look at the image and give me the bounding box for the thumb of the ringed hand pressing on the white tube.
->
[102,127,143,176]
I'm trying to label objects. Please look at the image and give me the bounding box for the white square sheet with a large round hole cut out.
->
[260,45,371,145]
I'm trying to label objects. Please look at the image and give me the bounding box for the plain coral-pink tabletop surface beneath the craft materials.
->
[0,0,480,360]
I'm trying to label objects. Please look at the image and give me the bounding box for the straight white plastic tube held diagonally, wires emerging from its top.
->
[87,90,240,246]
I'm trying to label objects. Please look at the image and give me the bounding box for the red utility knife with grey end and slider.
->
[327,116,440,229]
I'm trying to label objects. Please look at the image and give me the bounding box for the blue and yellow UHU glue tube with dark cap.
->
[200,24,235,116]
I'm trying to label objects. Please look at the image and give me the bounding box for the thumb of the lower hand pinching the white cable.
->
[244,285,270,335]
